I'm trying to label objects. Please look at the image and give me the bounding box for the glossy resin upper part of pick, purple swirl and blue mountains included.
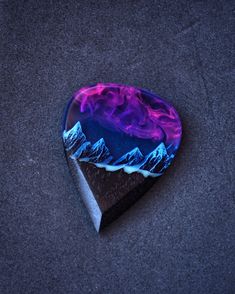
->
[63,83,182,177]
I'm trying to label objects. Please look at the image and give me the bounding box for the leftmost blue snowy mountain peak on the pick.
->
[63,121,86,151]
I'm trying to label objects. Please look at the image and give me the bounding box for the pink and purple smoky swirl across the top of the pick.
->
[67,83,182,147]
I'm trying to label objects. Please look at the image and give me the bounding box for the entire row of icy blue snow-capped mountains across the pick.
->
[63,121,173,177]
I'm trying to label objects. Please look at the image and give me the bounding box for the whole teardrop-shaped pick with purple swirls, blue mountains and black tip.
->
[62,83,182,231]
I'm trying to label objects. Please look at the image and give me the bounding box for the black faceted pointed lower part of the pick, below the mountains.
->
[66,157,156,232]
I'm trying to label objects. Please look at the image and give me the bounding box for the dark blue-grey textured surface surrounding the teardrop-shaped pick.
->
[0,0,235,294]
